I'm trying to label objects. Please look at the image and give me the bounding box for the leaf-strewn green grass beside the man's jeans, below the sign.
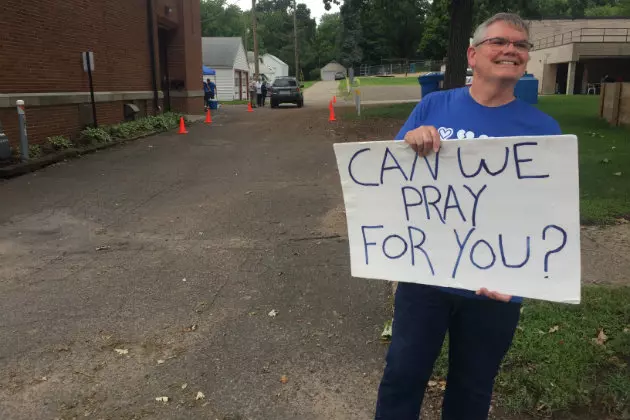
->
[434,286,630,418]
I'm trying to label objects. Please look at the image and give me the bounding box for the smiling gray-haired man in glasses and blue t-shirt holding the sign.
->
[375,13,561,420]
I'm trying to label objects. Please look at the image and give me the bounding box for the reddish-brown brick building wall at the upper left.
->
[0,0,203,150]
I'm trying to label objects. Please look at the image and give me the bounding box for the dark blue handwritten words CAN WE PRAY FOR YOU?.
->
[347,141,567,278]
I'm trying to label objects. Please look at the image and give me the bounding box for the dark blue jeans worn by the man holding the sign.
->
[376,283,521,420]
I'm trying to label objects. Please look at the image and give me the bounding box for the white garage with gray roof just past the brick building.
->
[201,37,249,101]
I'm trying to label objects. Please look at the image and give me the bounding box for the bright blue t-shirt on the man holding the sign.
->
[396,87,561,302]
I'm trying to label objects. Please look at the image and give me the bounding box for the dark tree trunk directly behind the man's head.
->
[444,0,474,89]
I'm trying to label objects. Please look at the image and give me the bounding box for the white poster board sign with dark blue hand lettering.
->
[334,136,580,303]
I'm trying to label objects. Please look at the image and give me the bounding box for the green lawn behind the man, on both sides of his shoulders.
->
[340,95,630,224]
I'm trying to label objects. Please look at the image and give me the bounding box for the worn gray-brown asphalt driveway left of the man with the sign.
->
[0,106,389,420]
